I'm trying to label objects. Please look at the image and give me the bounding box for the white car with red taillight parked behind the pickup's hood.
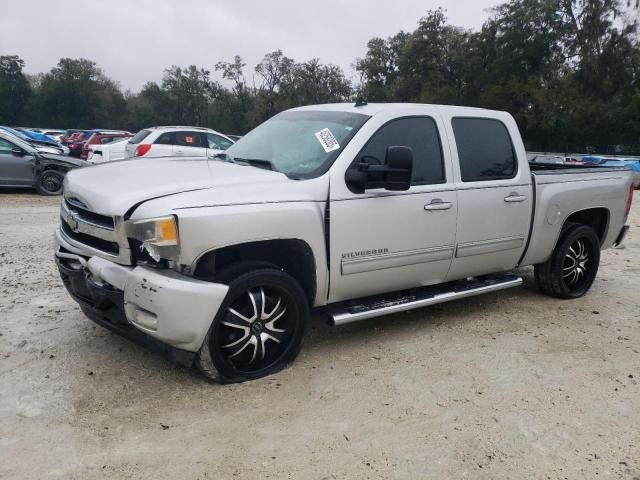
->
[126,126,235,158]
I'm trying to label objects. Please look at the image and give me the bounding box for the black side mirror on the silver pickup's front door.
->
[345,146,413,193]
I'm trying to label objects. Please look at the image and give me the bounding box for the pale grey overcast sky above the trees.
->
[0,0,502,91]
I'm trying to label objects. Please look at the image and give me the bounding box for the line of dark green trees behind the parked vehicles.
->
[0,0,640,153]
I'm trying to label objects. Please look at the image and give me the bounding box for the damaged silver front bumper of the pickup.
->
[55,228,228,366]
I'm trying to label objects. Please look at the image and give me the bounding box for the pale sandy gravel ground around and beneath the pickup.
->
[0,193,640,479]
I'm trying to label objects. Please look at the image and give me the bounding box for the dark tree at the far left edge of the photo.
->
[0,55,32,125]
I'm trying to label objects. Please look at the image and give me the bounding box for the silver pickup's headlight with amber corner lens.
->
[127,215,180,262]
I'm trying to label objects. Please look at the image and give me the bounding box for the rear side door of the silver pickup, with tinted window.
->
[446,117,533,280]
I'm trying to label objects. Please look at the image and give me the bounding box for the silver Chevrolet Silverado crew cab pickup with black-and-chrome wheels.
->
[55,102,633,382]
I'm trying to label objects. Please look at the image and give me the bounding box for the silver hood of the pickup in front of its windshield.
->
[64,157,296,216]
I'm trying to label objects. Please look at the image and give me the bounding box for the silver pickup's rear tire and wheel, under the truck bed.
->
[534,223,600,299]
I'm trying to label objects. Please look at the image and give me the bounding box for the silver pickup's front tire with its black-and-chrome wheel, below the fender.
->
[196,262,309,383]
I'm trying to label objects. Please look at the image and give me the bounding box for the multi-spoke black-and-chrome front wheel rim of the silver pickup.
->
[216,287,291,372]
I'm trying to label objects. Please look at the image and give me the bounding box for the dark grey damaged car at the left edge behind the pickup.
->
[0,132,87,195]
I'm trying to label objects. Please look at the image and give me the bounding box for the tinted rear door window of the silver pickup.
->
[451,117,518,182]
